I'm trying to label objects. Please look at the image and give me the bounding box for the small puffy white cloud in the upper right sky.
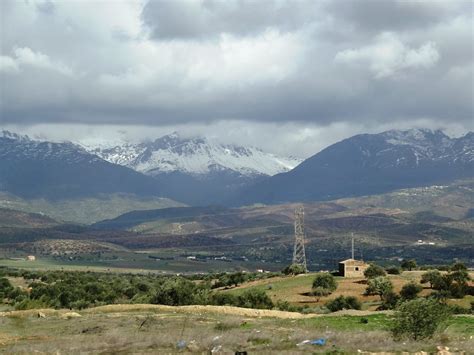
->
[335,32,440,78]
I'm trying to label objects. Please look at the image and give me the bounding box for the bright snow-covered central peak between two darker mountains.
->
[86,132,301,177]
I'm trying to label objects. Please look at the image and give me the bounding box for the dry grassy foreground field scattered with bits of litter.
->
[0,306,474,354]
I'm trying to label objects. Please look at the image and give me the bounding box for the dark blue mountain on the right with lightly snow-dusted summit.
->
[235,129,474,204]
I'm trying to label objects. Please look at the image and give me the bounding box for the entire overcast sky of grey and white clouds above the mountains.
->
[0,0,474,157]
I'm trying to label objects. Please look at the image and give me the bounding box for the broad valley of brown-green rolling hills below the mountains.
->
[0,180,474,273]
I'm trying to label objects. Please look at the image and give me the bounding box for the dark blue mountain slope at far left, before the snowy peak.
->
[0,131,161,199]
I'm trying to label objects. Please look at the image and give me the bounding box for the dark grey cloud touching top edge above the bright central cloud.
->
[142,0,319,39]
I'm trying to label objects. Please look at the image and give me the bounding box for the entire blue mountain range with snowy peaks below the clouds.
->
[0,129,474,205]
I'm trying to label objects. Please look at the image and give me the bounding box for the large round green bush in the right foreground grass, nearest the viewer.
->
[392,298,450,340]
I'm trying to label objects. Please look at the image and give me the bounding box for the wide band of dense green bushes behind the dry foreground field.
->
[0,270,274,310]
